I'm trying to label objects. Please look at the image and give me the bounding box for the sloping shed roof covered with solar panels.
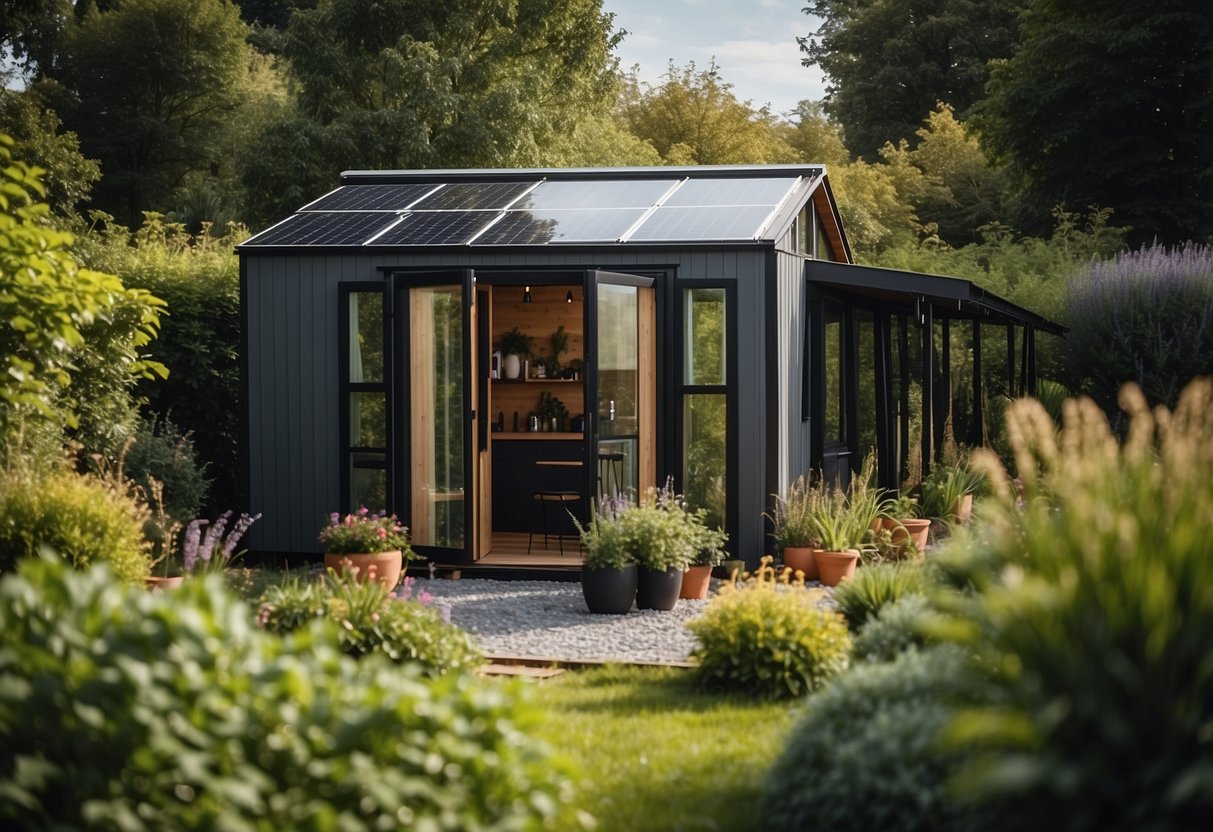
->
[241,167,820,247]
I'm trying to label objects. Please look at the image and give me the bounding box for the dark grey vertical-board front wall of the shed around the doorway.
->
[243,246,766,560]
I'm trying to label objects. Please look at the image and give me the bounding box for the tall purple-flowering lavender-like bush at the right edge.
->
[1066,245,1213,417]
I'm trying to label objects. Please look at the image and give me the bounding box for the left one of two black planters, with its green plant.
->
[573,496,637,615]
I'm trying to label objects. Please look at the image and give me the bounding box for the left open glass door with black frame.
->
[397,272,477,562]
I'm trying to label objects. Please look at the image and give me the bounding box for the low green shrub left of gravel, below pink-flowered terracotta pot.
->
[257,571,483,676]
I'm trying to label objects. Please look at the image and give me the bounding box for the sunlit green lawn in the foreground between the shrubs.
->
[521,666,796,832]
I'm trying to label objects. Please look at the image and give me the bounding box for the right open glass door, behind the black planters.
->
[586,272,656,501]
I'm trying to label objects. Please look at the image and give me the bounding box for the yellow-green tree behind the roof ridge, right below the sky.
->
[620,62,798,165]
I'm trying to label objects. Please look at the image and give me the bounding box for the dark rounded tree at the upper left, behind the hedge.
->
[42,0,250,224]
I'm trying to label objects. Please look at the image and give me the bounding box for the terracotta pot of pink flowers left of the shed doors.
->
[318,507,418,589]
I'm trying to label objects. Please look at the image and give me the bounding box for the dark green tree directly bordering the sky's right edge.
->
[798,0,1025,159]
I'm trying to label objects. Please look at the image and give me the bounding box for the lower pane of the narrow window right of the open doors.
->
[683,393,728,528]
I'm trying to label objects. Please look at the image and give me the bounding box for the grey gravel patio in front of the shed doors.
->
[414,579,839,662]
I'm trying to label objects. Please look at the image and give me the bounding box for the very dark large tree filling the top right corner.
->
[979,0,1213,243]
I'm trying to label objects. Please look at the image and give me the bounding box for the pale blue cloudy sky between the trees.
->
[603,0,825,113]
